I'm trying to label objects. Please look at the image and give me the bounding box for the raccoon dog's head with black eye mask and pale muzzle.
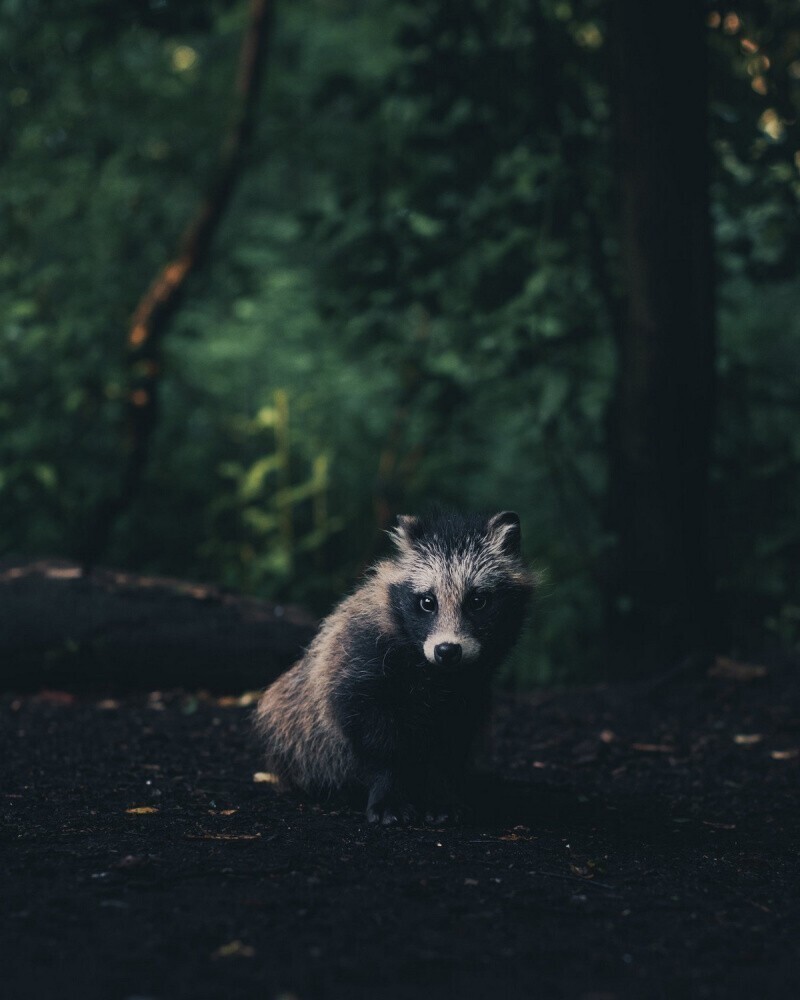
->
[391,512,531,669]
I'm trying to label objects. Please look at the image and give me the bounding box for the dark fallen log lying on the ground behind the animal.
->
[0,559,315,693]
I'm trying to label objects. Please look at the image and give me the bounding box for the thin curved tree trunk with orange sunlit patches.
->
[82,0,272,573]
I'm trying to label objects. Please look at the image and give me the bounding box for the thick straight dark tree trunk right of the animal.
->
[608,0,715,673]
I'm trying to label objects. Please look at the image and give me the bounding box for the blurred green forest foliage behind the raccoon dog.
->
[0,0,800,684]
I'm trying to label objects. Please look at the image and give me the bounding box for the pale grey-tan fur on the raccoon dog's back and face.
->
[256,514,534,791]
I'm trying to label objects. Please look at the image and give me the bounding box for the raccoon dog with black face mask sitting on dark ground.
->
[256,511,534,825]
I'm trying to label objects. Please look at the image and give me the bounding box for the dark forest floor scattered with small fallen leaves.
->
[0,663,800,1000]
